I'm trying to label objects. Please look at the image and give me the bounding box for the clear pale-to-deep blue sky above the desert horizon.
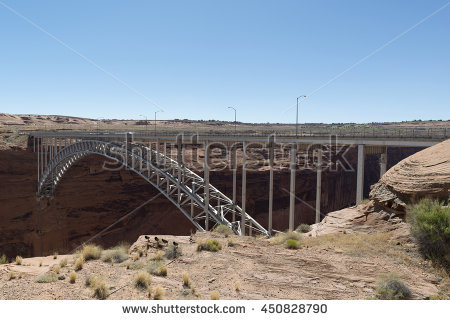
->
[0,0,450,122]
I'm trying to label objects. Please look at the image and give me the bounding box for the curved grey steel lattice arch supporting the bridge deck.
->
[37,140,269,236]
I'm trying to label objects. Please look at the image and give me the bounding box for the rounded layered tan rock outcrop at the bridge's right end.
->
[370,140,450,213]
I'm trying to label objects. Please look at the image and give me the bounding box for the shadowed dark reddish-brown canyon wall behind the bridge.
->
[0,147,420,257]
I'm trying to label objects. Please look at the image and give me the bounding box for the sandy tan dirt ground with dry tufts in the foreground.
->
[0,225,449,299]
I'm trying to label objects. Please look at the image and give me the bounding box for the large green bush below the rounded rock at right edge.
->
[407,199,450,264]
